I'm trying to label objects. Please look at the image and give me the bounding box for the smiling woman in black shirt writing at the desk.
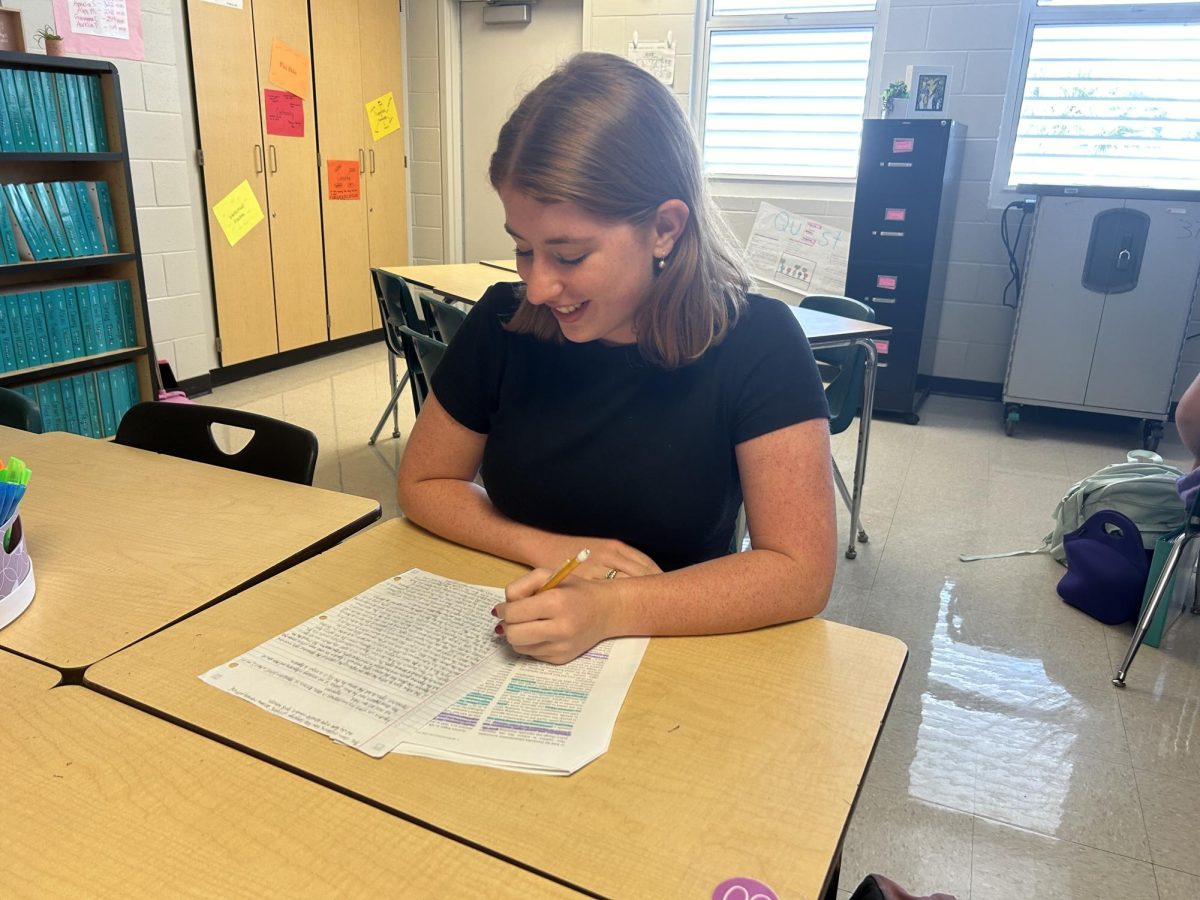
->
[398,53,836,662]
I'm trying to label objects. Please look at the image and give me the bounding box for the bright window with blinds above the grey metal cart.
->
[994,0,1200,193]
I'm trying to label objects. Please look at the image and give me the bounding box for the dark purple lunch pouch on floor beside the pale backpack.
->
[1058,509,1150,625]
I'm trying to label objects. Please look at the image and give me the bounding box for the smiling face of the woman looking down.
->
[499,186,667,343]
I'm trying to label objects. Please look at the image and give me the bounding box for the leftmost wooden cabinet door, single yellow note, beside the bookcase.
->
[187,0,278,366]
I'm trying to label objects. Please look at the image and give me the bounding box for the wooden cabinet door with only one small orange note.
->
[310,0,369,337]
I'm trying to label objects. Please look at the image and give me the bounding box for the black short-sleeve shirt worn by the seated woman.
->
[433,284,828,570]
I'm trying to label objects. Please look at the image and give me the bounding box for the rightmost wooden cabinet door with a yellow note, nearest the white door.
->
[359,0,408,328]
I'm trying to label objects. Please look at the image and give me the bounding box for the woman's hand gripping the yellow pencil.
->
[496,569,619,665]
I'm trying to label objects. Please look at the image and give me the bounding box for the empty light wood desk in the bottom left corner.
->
[0,686,575,898]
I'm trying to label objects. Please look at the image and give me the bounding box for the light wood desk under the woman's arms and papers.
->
[85,520,906,899]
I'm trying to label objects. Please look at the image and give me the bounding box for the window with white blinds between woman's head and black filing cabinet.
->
[700,0,876,179]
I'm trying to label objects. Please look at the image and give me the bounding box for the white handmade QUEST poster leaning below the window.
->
[746,203,850,294]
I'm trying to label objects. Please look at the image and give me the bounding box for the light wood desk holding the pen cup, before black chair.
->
[0,427,379,680]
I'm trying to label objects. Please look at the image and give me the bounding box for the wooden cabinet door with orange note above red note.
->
[254,0,329,350]
